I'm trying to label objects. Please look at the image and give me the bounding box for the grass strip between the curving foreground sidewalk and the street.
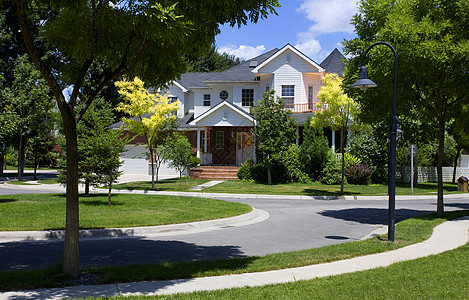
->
[0,210,469,290]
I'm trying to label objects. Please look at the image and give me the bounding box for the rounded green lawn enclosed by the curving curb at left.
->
[0,194,251,230]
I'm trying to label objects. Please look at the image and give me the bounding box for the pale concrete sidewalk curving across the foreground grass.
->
[0,217,469,299]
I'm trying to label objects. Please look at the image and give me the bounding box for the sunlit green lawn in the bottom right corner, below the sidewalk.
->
[118,245,469,300]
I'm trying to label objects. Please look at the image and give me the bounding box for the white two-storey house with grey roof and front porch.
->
[119,44,345,176]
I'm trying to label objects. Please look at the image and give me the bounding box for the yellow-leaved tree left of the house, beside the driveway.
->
[115,77,179,189]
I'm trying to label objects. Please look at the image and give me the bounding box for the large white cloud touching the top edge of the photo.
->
[298,0,358,40]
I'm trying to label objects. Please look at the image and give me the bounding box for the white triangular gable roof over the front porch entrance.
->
[190,101,255,126]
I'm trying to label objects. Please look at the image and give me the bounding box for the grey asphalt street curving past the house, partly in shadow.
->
[0,180,469,271]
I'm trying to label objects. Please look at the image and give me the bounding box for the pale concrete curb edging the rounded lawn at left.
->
[0,208,270,243]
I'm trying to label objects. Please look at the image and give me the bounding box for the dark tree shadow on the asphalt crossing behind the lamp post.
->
[319,208,433,225]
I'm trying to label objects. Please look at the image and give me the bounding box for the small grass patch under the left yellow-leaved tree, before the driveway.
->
[112,177,210,192]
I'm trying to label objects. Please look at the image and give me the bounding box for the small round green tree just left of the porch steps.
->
[164,133,200,178]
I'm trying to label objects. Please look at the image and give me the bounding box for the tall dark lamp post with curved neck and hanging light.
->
[352,42,398,242]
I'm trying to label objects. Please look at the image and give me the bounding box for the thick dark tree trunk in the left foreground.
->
[61,113,80,278]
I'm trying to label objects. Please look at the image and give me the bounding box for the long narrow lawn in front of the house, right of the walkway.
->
[203,180,458,196]
